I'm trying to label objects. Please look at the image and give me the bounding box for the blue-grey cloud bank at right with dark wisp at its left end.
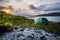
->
[30,3,60,13]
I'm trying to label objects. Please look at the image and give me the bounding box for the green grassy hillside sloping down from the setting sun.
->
[0,11,34,25]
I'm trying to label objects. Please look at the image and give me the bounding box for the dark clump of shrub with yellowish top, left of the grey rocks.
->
[0,23,13,33]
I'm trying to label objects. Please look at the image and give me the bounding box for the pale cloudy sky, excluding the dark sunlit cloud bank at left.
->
[0,0,60,16]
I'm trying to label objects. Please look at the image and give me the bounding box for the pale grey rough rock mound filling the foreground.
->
[0,28,60,40]
